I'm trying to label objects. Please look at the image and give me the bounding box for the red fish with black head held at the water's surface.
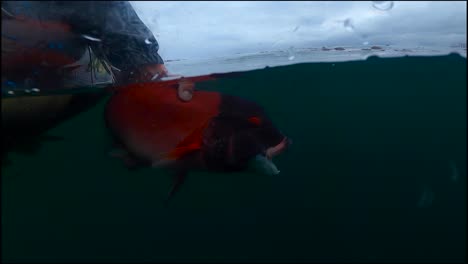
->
[105,76,290,202]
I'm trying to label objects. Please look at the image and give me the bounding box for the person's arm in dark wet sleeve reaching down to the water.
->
[65,1,167,82]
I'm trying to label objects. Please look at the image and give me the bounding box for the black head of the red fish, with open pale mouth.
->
[205,98,292,174]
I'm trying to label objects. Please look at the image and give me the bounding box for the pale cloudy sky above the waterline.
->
[131,1,466,59]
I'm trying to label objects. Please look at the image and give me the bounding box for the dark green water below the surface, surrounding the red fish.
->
[1,55,467,262]
